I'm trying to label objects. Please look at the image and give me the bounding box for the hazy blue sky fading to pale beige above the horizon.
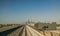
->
[0,0,60,24]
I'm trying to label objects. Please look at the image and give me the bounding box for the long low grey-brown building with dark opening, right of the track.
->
[34,22,57,30]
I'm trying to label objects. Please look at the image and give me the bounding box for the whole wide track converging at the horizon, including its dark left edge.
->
[0,25,44,36]
